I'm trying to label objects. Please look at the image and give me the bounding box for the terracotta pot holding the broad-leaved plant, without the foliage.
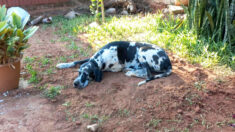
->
[0,60,20,93]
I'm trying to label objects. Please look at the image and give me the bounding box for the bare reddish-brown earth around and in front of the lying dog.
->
[0,27,235,132]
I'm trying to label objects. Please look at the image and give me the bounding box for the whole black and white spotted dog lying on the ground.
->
[56,41,172,88]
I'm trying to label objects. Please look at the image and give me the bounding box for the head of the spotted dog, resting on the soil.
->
[73,61,103,89]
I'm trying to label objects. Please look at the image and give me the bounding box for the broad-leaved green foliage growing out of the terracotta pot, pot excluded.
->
[0,5,38,64]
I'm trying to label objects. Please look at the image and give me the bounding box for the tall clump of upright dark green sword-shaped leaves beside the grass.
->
[187,0,235,46]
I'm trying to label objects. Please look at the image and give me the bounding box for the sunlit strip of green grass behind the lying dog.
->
[51,13,235,74]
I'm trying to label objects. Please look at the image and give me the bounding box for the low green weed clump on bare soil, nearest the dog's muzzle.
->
[43,86,64,99]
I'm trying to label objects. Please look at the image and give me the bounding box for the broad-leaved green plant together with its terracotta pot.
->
[0,5,38,92]
